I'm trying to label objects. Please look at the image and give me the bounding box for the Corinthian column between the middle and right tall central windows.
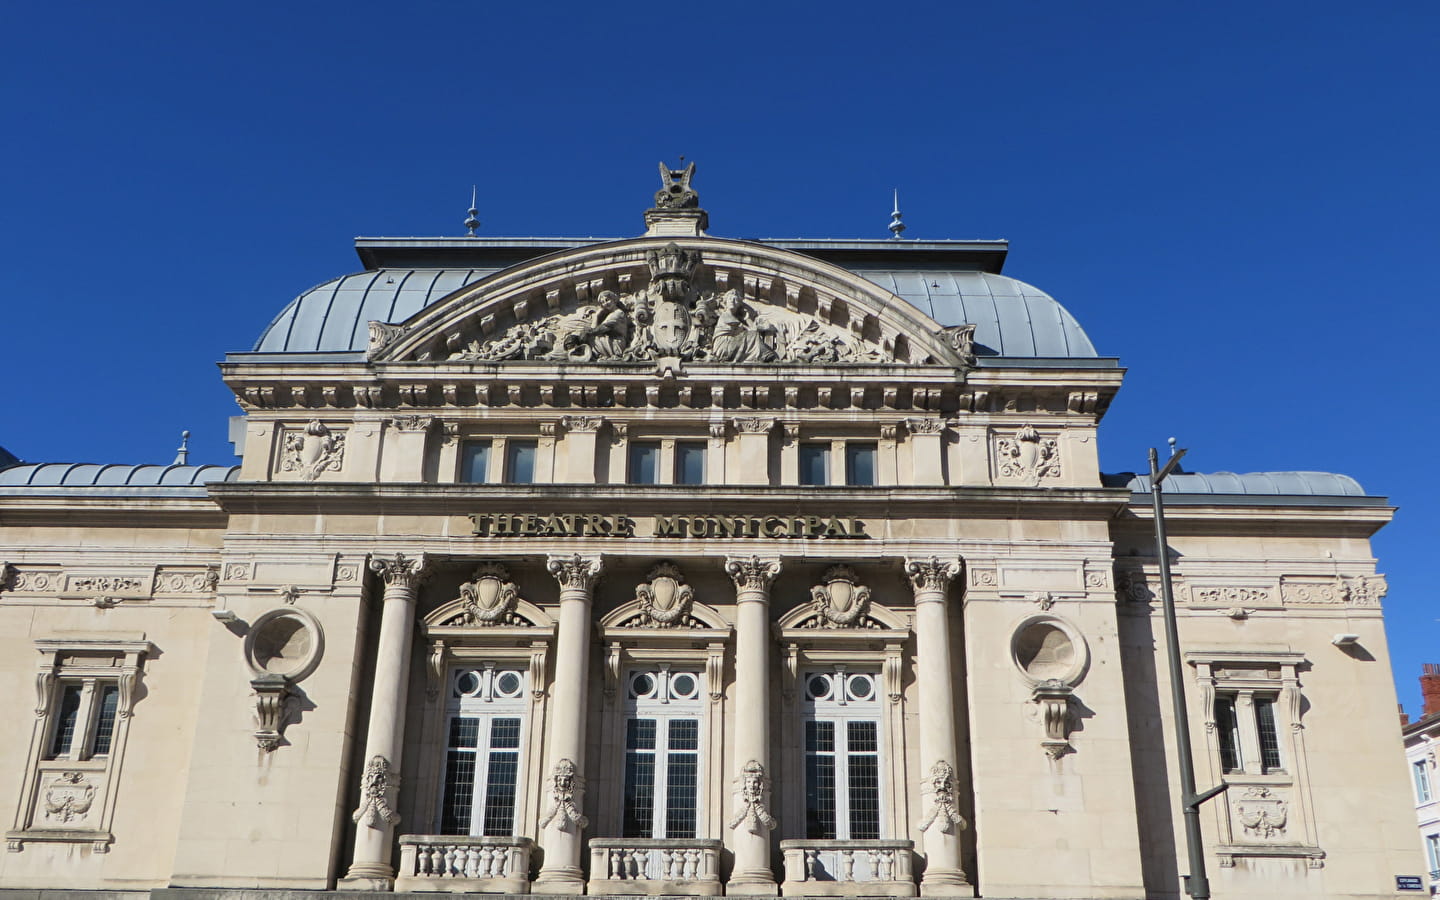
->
[724,556,780,896]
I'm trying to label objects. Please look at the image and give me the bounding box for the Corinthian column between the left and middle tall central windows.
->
[534,554,600,894]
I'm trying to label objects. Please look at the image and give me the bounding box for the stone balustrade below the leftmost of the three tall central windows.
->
[395,834,531,894]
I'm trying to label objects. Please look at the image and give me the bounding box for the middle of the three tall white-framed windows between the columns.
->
[621,667,703,838]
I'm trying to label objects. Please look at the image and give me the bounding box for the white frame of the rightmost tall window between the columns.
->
[799,664,888,841]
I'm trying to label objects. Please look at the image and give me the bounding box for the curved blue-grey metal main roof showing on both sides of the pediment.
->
[255,268,1099,359]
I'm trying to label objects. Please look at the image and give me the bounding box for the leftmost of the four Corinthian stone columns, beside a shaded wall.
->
[340,553,428,890]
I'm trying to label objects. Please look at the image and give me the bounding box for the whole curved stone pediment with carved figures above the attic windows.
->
[367,238,966,367]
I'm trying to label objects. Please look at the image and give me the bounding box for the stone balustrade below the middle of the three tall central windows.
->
[588,838,721,897]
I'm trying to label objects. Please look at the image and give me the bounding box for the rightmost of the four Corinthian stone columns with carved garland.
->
[904,556,975,897]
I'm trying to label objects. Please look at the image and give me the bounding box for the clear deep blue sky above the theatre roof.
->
[0,0,1440,707]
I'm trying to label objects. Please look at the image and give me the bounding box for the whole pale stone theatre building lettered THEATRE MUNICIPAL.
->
[0,167,1424,900]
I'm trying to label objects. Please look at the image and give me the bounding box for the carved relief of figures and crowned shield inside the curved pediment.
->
[437,243,896,363]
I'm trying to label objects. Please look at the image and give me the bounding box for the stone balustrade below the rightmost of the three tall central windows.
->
[780,841,916,897]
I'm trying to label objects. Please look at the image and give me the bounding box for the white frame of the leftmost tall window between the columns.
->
[435,662,530,837]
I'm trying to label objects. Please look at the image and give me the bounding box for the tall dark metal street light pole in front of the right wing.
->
[1151,438,1230,900]
